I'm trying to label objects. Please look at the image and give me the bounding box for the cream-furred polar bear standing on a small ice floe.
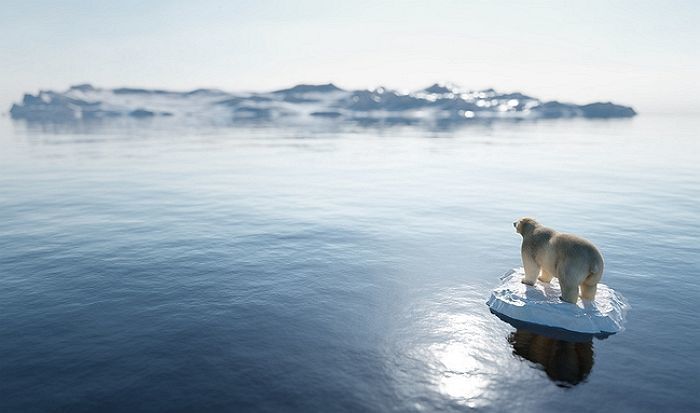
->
[513,218,605,304]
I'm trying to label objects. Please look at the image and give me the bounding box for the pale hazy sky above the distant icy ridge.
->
[0,0,700,112]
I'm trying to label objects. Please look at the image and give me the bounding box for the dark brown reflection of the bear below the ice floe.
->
[508,328,593,387]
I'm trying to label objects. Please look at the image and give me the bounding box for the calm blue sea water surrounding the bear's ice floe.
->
[0,116,700,412]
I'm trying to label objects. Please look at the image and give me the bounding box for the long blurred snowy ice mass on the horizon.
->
[10,83,636,124]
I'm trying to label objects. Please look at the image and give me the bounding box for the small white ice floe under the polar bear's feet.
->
[486,268,629,337]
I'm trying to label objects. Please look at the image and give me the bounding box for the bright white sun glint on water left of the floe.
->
[390,287,512,411]
